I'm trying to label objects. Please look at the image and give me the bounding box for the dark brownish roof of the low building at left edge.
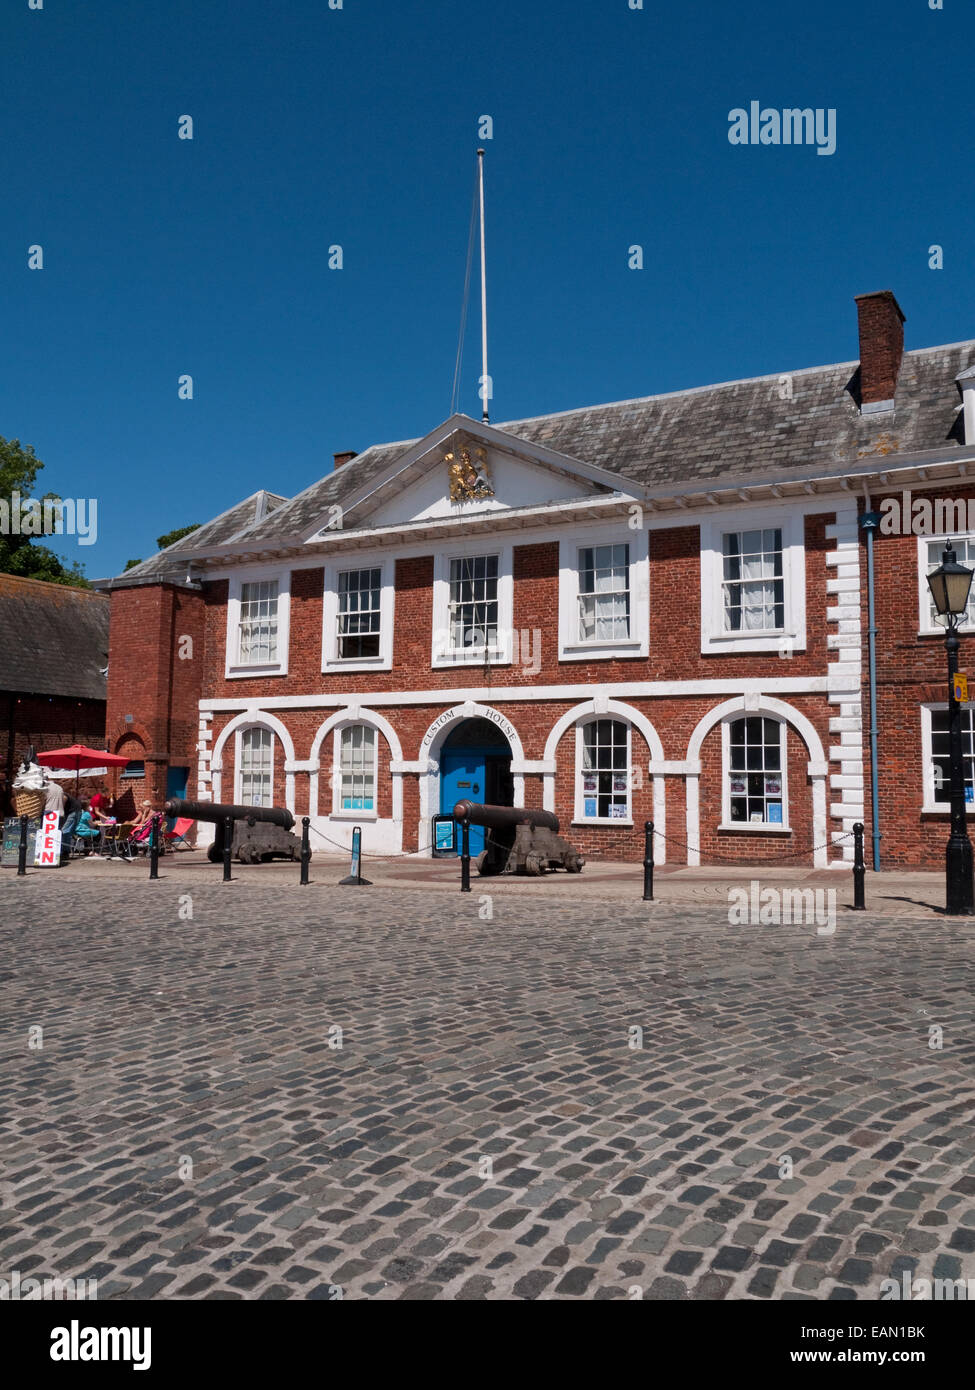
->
[0,574,108,699]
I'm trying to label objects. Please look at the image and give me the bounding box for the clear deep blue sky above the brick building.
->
[0,0,975,577]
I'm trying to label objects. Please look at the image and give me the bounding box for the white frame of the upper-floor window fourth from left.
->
[559,524,650,662]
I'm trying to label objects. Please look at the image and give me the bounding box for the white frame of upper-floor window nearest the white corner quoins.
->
[701,509,805,656]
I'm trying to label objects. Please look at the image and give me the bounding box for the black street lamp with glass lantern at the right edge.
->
[928,541,975,917]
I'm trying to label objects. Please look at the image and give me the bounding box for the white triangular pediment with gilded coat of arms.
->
[300,416,633,539]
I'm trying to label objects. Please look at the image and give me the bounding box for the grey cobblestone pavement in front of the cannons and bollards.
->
[0,870,975,1300]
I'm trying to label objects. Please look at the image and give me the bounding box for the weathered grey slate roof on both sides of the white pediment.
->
[106,339,975,577]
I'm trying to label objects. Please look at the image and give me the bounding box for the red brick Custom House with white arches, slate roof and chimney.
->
[96,292,975,866]
